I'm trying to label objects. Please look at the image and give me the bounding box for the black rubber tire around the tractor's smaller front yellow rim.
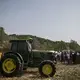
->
[39,60,56,77]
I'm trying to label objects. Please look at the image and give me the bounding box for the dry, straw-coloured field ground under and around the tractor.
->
[0,63,80,80]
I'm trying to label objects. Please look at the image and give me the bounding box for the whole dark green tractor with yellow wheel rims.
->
[0,40,56,77]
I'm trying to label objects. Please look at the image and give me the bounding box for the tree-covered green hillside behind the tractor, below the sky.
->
[0,27,80,51]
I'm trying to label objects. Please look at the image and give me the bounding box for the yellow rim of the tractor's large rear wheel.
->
[2,58,16,73]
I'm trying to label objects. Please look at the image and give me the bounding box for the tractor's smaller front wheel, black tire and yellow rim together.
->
[39,60,56,77]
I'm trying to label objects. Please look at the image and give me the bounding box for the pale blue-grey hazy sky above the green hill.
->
[0,0,80,43]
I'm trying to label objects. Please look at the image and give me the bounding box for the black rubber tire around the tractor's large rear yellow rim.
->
[1,54,22,77]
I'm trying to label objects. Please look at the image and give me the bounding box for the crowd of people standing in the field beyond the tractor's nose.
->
[52,50,80,64]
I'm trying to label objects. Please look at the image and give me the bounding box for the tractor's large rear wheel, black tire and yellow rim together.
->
[1,54,22,77]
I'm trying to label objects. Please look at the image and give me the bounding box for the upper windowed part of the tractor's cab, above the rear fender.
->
[10,40,32,52]
